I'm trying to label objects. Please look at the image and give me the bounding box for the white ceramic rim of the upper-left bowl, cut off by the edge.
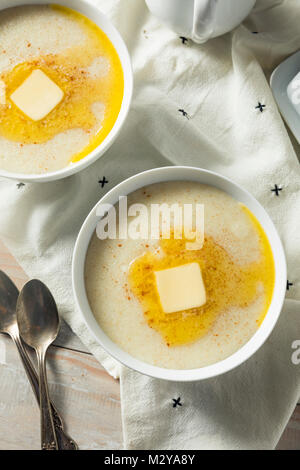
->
[0,0,133,182]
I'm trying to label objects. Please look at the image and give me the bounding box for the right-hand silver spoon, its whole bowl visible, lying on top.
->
[16,279,64,450]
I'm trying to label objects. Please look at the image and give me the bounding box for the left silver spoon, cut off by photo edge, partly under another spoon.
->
[0,270,78,450]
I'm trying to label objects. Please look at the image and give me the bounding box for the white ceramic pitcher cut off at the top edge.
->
[146,0,256,43]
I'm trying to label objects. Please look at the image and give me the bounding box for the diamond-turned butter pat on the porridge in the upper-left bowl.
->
[10,69,64,121]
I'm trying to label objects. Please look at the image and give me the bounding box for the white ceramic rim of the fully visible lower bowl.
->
[72,166,287,382]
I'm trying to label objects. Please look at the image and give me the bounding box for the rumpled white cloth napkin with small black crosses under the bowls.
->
[0,0,300,449]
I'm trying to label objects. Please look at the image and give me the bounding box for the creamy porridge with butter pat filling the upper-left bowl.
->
[0,5,123,173]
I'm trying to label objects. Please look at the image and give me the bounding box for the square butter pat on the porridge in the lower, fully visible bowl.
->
[154,263,206,313]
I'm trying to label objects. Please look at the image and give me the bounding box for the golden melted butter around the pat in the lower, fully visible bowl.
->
[129,205,275,346]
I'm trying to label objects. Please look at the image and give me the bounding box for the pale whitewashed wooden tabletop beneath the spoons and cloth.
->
[0,241,300,450]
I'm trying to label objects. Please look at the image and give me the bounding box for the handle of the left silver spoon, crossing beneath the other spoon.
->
[11,333,78,450]
